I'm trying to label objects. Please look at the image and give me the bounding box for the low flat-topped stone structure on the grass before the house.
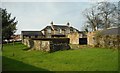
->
[24,38,70,52]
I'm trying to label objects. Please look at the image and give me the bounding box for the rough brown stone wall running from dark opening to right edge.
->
[87,31,120,48]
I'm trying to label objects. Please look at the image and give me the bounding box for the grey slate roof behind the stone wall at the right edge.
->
[101,27,120,35]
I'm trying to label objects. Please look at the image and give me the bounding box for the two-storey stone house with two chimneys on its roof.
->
[41,22,79,38]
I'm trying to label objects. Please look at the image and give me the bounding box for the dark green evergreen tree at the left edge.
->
[0,8,18,40]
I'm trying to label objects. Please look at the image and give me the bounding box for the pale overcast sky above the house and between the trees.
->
[2,0,118,34]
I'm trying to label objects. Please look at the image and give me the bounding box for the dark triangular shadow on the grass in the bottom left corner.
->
[2,56,48,72]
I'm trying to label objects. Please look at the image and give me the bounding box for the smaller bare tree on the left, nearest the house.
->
[84,6,101,31]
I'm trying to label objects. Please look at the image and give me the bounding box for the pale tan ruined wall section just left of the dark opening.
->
[68,32,80,44]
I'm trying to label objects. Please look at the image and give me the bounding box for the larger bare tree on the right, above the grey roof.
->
[98,2,118,29]
